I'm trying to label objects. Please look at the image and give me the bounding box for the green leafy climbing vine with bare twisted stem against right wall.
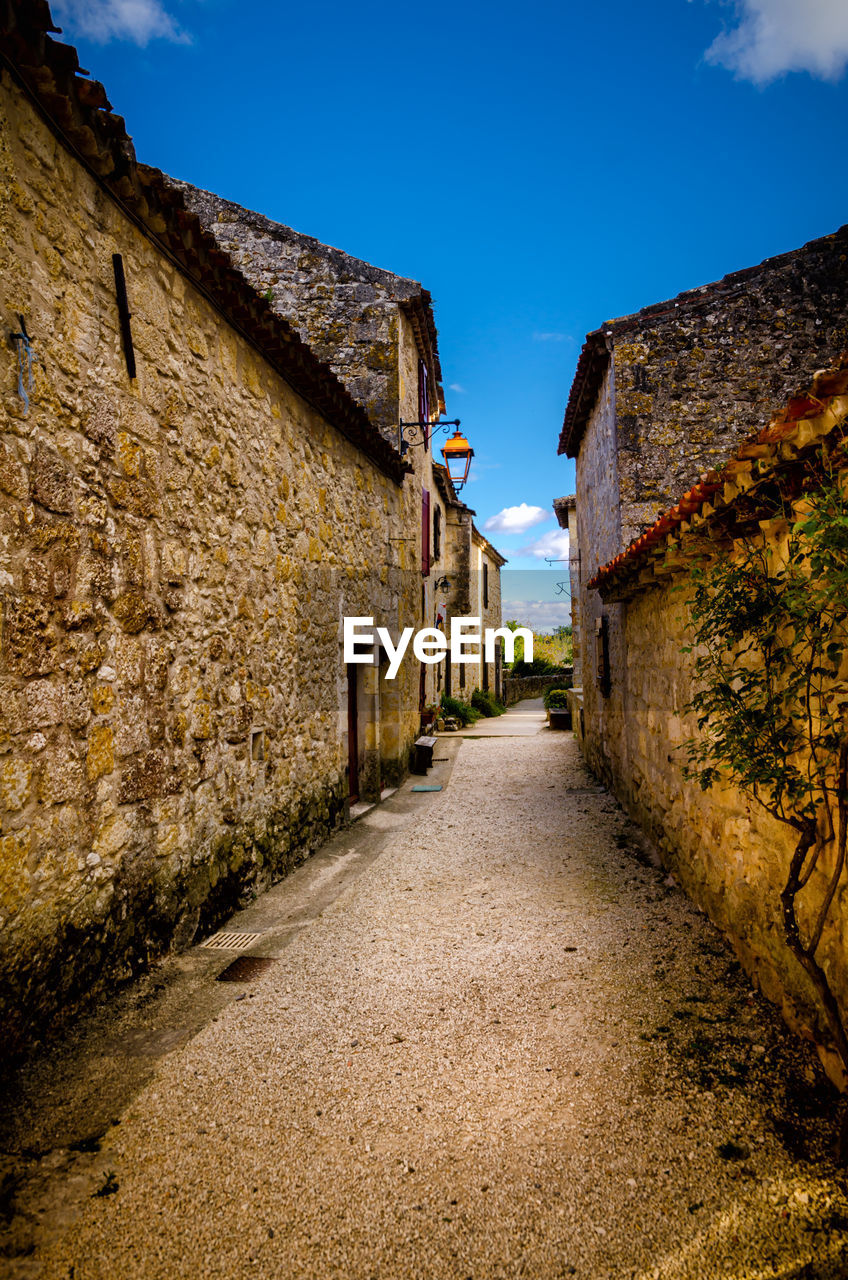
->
[685,454,848,1153]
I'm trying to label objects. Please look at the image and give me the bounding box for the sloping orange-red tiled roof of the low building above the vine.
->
[588,352,848,598]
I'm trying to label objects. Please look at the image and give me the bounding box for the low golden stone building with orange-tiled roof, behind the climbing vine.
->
[588,381,848,1085]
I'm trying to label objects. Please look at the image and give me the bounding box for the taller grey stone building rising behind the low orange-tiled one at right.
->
[559,227,848,781]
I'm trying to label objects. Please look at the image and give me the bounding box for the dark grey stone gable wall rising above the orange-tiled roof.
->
[612,227,848,550]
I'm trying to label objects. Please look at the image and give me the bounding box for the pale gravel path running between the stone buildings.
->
[31,731,848,1280]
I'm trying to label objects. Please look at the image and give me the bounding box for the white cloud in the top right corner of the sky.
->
[706,0,848,84]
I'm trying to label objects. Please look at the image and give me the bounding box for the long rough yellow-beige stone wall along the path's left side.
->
[0,77,420,1048]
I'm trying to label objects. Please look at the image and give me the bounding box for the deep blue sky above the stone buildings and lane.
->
[54,0,848,624]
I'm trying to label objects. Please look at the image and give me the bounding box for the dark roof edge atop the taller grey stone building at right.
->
[557,227,847,458]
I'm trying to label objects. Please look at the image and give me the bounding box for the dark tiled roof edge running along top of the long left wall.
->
[0,0,410,484]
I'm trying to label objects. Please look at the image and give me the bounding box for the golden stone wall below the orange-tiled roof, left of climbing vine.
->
[603,576,848,1082]
